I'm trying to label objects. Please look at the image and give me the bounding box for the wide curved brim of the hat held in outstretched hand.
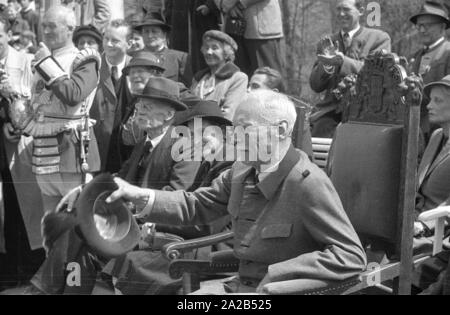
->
[76,174,140,259]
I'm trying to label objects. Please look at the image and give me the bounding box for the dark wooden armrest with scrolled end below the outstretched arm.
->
[162,232,234,260]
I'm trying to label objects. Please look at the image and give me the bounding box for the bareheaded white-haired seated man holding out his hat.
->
[107,91,366,294]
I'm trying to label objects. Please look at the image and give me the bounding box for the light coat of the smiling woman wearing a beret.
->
[191,62,248,120]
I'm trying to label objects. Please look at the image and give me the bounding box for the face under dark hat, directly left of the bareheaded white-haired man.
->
[188,119,224,158]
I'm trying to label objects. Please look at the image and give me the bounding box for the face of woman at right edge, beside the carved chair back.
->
[427,86,450,126]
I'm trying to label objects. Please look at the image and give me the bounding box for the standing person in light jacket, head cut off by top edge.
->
[215,0,283,76]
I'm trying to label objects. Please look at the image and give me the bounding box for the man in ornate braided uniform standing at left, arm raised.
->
[24,6,101,212]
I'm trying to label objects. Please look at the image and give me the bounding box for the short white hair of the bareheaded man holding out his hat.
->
[244,89,297,135]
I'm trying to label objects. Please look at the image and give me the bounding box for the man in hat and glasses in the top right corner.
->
[410,1,450,143]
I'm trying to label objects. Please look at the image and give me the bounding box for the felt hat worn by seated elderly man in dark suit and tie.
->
[136,77,187,111]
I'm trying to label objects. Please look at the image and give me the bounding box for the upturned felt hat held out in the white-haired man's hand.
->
[76,174,140,259]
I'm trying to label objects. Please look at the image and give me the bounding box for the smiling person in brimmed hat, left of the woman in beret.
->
[135,12,192,86]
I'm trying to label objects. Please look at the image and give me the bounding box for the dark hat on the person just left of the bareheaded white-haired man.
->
[175,99,233,126]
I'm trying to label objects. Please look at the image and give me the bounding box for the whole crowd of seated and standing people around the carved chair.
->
[0,0,450,295]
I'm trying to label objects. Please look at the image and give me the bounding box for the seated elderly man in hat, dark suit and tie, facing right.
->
[32,78,201,294]
